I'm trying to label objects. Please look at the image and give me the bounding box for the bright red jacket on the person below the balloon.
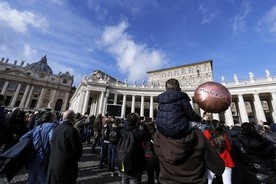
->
[203,130,235,168]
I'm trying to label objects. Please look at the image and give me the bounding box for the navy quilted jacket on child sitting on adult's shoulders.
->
[156,90,202,138]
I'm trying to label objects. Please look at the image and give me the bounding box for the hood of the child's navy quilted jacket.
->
[157,90,191,104]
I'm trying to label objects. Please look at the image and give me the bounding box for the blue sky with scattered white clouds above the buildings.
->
[0,0,276,86]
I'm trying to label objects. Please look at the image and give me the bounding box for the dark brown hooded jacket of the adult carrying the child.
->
[154,130,225,184]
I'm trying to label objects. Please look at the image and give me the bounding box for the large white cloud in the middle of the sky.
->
[101,21,166,81]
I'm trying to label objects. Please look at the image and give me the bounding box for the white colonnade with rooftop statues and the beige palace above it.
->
[69,60,276,126]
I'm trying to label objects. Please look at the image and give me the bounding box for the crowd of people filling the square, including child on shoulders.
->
[0,76,276,184]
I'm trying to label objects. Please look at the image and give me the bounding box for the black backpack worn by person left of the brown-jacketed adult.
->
[117,131,136,174]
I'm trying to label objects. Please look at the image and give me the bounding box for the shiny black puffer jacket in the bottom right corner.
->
[232,134,276,184]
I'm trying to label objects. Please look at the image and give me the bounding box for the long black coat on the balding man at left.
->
[47,121,82,184]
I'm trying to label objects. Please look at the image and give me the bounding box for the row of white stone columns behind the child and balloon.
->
[70,86,276,126]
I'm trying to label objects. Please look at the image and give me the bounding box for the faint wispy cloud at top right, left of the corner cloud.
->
[232,2,252,33]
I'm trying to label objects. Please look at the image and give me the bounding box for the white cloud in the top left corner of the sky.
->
[0,2,49,33]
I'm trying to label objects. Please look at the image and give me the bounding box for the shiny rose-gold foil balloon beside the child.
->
[194,82,232,113]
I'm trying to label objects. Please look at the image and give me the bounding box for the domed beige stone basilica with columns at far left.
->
[0,55,74,111]
